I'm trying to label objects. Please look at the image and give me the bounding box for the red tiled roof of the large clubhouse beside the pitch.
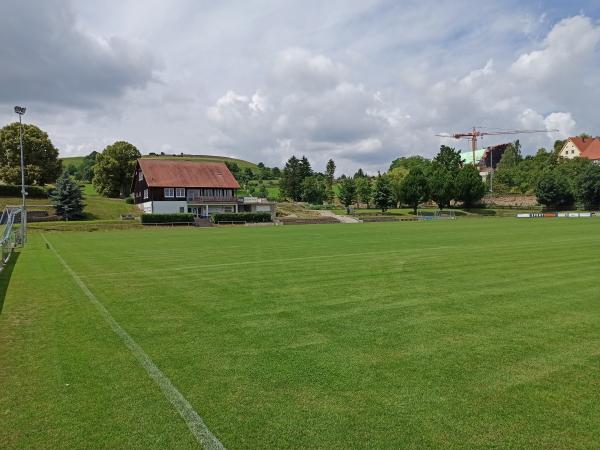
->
[138,159,240,189]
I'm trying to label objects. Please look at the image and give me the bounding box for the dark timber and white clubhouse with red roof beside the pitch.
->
[131,158,276,217]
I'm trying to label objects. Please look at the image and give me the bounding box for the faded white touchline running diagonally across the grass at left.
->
[42,233,225,450]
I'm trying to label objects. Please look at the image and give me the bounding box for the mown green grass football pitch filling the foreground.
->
[0,218,600,449]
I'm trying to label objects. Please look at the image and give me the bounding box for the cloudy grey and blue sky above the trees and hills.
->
[0,0,600,172]
